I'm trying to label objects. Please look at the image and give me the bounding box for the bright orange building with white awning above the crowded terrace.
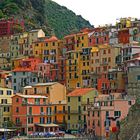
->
[12,94,66,135]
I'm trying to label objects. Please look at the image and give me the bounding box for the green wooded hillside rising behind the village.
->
[0,0,91,38]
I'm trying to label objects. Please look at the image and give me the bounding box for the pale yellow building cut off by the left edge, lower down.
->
[0,87,13,127]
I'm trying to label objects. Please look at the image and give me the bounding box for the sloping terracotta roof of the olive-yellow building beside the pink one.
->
[67,88,95,96]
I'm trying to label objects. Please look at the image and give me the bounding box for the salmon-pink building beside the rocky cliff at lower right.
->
[87,93,135,137]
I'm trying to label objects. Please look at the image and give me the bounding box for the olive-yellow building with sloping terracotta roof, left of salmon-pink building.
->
[67,88,98,130]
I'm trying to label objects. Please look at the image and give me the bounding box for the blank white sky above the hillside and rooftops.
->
[53,0,140,27]
